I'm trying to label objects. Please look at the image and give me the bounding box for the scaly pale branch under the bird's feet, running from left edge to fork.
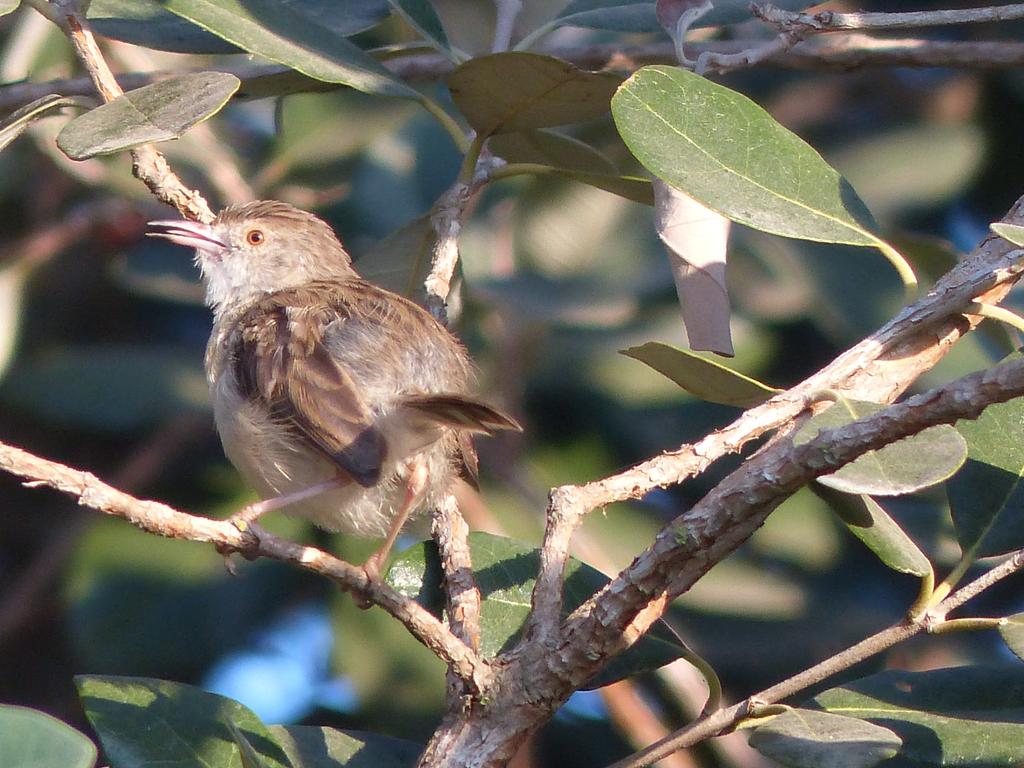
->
[0,443,493,690]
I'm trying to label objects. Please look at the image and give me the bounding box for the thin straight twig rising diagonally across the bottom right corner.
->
[608,550,1024,768]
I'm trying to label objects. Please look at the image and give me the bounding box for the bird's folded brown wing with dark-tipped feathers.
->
[234,291,387,486]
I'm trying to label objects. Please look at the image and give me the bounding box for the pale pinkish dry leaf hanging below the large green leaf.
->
[653,179,733,357]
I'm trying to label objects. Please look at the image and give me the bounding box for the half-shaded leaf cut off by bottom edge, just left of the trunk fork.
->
[270,725,423,768]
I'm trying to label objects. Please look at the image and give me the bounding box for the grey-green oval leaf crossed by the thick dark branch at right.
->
[793,397,967,496]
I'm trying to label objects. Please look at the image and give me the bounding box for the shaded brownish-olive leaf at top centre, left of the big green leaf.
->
[447,51,622,136]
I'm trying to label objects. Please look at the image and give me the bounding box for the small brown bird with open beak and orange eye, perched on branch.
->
[150,202,520,577]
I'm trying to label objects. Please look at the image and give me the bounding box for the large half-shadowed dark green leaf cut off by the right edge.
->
[946,352,1024,557]
